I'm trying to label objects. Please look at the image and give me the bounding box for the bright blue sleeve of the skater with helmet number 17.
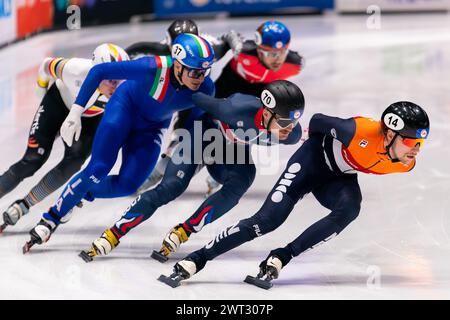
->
[75,57,156,107]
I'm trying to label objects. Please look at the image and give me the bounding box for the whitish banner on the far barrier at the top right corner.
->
[336,0,450,12]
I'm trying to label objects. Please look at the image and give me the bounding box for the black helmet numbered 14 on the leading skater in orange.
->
[381,101,430,139]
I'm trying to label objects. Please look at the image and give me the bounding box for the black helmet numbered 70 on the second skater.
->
[261,80,305,128]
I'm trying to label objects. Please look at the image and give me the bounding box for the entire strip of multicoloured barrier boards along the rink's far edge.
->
[0,0,450,46]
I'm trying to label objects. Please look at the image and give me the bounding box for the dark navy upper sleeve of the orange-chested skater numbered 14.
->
[309,113,356,147]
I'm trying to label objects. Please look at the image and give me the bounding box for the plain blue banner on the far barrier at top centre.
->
[154,0,334,18]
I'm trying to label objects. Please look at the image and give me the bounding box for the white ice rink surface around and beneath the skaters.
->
[0,14,450,299]
